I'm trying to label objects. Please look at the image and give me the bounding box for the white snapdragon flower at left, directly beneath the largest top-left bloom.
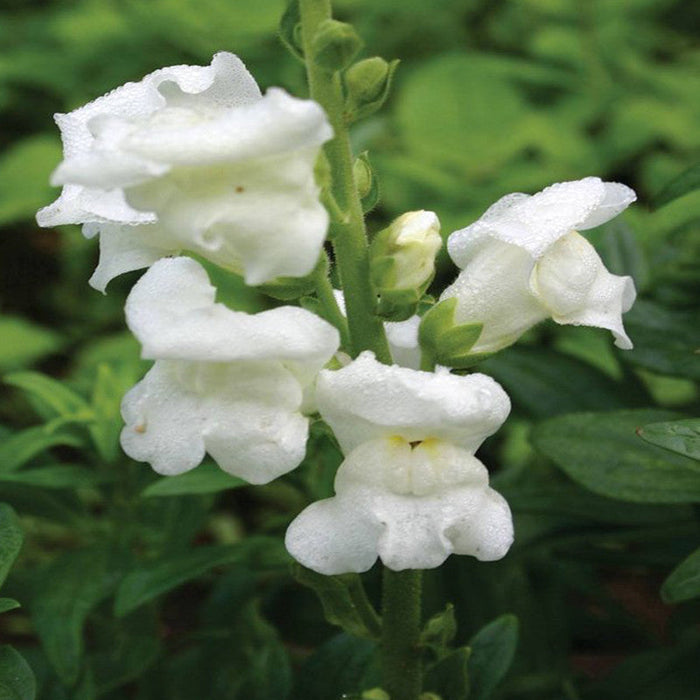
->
[121,258,339,484]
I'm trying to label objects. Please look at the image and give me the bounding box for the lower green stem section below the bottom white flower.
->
[382,568,422,700]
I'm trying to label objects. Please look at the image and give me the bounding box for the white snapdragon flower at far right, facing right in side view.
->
[440,177,636,353]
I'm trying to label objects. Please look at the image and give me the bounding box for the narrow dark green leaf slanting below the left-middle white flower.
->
[114,545,247,617]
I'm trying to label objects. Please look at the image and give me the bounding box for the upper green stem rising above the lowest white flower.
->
[299,0,391,364]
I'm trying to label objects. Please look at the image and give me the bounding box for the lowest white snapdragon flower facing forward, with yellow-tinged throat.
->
[285,352,513,575]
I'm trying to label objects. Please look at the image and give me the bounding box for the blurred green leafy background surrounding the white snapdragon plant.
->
[0,0,700,700]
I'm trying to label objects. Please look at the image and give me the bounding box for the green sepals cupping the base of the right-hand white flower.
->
[418,297,486,369]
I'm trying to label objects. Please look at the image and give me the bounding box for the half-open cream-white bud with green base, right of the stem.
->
[370,211,442,321]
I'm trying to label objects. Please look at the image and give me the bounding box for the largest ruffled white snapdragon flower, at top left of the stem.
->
[37,53,332,290]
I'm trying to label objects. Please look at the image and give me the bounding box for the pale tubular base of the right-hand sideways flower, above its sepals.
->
[440,239,549,353]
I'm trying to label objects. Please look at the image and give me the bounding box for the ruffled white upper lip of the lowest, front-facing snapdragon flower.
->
[316,352,510,454]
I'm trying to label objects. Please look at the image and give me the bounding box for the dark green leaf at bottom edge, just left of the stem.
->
[292,633,380,700]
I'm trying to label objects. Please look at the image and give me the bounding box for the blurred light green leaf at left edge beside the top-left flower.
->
[0,134,61,225]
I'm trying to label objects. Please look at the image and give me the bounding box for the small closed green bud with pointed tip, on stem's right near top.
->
[344,56,399,123]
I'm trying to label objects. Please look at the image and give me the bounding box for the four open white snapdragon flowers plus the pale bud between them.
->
[37,53,635,574]
